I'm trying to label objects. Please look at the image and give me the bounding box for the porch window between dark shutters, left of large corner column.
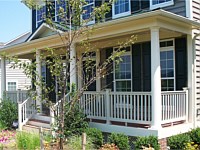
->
[114,47,132,91]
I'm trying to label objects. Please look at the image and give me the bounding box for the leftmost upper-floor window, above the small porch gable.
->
[36,5,46,27]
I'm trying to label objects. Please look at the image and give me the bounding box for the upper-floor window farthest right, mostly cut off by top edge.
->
[150,0,174,9]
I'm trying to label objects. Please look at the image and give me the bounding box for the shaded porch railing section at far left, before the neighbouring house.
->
[5,90,28,103]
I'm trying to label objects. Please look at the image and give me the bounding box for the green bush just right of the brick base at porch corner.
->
[167,133,191,149]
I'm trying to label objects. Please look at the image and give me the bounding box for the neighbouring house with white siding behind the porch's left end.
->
[0,32,31,102]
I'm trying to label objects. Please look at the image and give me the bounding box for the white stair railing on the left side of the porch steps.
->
[18,97,36,130]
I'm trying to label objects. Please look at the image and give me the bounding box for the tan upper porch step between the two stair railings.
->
[27,119,51,129]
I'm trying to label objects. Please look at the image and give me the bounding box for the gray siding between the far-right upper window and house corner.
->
[163,0,186,17]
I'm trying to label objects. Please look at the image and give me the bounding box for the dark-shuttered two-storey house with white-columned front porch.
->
[1,0,200,149]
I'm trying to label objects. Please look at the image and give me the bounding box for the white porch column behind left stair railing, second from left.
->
[36,50,42,112]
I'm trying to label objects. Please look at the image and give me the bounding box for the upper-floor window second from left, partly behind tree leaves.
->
[55,0,66,22]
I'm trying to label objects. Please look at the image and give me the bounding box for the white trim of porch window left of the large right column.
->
[113,45,133,92]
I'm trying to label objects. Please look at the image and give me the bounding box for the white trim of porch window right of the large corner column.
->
[160,39,176,91]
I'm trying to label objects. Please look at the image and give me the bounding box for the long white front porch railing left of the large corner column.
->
[81,90,151,124]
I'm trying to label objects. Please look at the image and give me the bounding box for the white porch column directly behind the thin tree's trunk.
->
[70,43,77,88]
